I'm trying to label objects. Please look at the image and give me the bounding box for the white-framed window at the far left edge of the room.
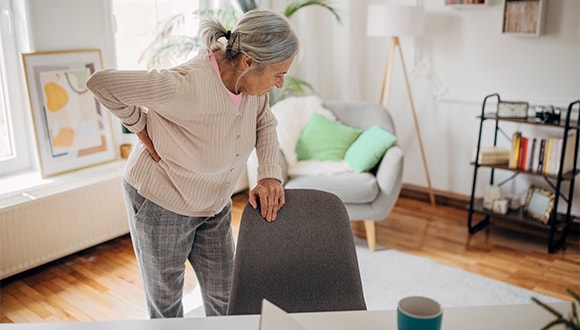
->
[0,0,34,177]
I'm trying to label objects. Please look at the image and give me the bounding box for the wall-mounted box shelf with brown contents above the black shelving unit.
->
[502,0,547,36]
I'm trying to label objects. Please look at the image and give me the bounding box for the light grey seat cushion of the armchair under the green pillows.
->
[285,172,379,204]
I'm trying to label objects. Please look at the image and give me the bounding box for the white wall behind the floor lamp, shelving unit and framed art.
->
[29,0,580,215]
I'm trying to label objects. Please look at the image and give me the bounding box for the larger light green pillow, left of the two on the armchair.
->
[296,112,362,161]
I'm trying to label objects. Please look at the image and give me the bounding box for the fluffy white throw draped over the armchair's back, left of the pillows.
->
[271,95,336,168]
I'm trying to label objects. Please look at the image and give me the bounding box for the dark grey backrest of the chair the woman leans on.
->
[228,189,366,315]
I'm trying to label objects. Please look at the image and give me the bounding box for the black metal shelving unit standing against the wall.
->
[467,93,580,253]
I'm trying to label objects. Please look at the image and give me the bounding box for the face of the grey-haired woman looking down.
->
[240,57,294,96]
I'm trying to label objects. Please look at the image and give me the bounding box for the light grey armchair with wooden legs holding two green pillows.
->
[248,101,403,251]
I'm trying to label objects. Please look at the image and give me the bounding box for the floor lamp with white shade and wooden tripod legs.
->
[367,4,435,205]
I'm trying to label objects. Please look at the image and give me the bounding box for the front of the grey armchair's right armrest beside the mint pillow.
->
[376,145,404,195]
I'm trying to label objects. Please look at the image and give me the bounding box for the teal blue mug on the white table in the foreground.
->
[397,296,443,330]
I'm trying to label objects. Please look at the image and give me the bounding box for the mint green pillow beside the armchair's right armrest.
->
[344,125,397,172]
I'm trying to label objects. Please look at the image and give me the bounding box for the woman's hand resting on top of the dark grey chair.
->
[248,178,285,222]
